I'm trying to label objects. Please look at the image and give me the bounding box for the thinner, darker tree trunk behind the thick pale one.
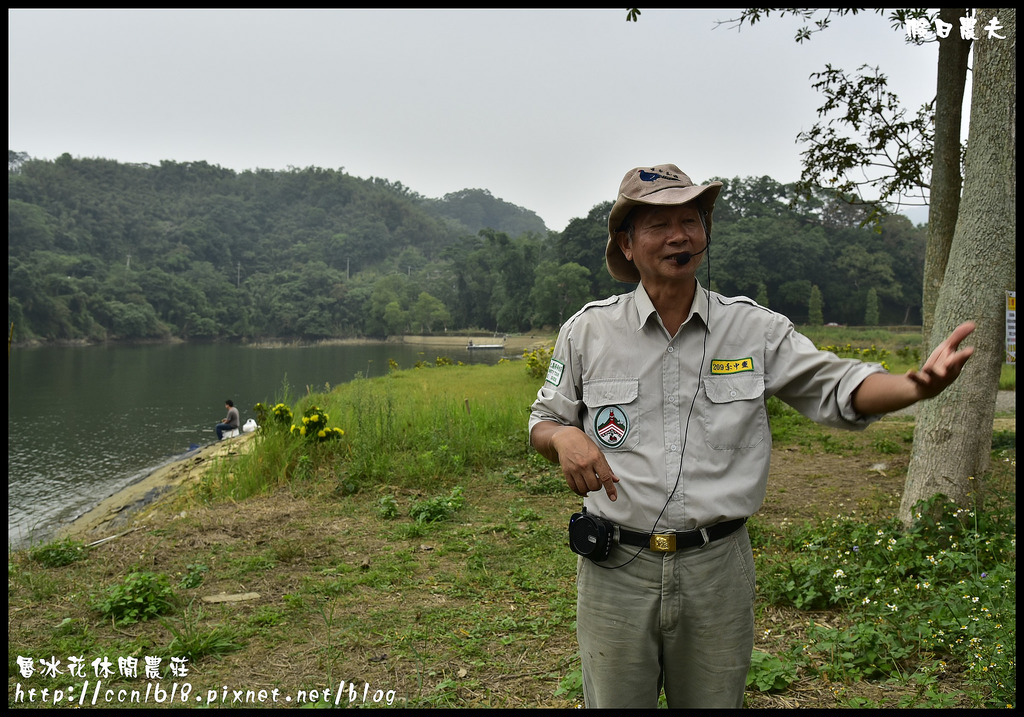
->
[921,7,981,348]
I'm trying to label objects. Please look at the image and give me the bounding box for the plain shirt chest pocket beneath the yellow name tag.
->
[703,376,769,450]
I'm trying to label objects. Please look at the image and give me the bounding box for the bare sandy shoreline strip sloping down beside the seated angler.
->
[54,433,255,542]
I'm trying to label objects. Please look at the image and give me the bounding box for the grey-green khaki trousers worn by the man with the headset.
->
[577,526,755,709]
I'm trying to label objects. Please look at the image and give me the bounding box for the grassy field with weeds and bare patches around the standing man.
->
[8,336,1016,708]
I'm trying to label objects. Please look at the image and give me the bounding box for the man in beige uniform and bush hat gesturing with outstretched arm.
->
[529,164,974,708]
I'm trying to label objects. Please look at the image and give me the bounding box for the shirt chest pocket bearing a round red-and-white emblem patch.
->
[583,378,640,451]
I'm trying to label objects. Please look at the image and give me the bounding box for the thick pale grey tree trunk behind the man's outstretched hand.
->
[900,8,1017,526]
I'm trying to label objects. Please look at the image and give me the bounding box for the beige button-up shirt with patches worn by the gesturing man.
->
[529,285,884,532]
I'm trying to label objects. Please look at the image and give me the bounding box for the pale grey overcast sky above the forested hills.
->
[8,8,937,230]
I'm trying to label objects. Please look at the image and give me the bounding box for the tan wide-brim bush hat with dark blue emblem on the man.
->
[604,164,722,284]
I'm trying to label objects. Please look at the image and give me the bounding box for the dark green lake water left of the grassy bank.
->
[7,343,503,547]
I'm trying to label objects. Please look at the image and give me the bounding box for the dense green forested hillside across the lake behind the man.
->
[7,151,926,342]
